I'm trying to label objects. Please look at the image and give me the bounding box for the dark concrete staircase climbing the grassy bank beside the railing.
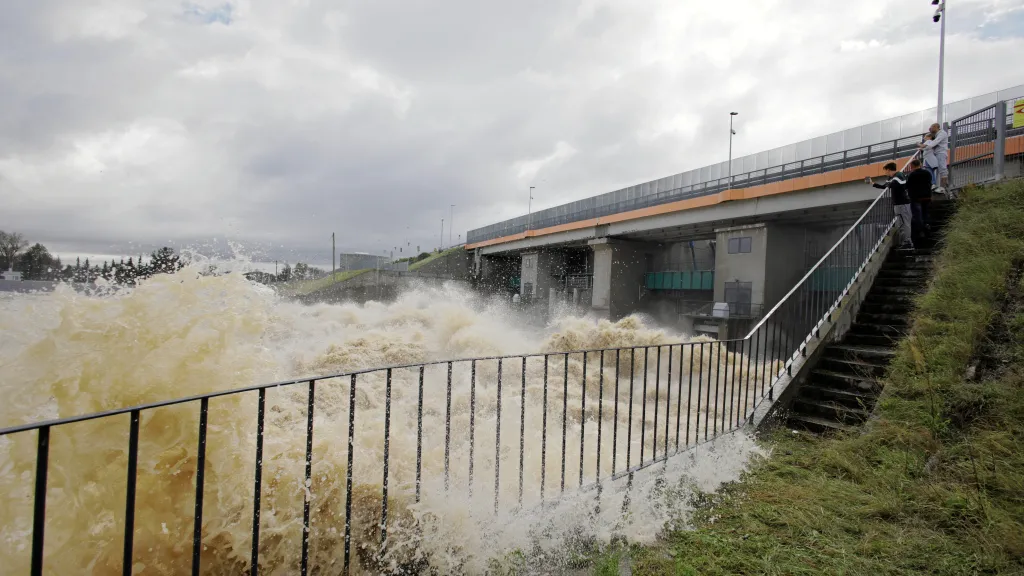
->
[786,196,954,434]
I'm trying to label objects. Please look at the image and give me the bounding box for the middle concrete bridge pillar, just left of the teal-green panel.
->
[589,238,651,321]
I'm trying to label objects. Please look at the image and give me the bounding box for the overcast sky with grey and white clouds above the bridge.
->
[0,0,1024,262]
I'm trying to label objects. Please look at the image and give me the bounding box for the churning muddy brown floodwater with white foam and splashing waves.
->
[0,269,770,575]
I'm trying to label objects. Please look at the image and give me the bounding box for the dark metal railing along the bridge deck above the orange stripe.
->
[468,134,924,244]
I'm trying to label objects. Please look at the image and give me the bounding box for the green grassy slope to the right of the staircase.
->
[614,181,1024,575]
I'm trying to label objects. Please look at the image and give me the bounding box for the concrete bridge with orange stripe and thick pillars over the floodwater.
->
[466,85,1024,338]
